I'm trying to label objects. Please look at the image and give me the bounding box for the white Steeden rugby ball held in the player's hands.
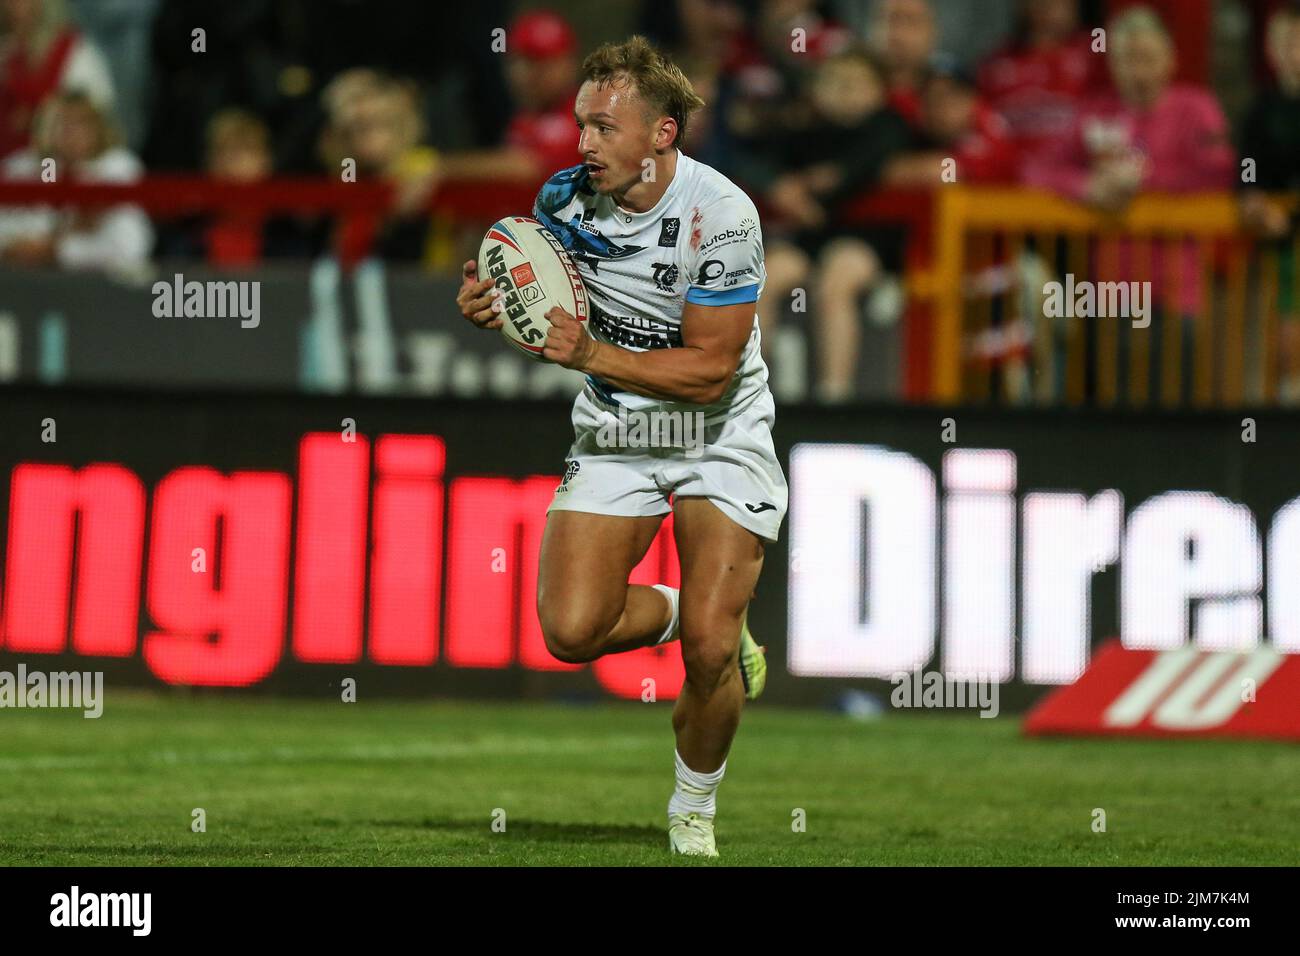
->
[478,216,586,362]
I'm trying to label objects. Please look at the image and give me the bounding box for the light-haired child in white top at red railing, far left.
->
[0,92,153,273]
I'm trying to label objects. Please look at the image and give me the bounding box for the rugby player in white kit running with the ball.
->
[456,36,788,856]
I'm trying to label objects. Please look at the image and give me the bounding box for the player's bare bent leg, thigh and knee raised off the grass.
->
[537,510,672,663]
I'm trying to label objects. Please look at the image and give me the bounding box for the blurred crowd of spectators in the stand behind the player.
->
[0,0,1300,401]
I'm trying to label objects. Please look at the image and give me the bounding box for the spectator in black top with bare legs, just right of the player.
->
[755,48,910,402]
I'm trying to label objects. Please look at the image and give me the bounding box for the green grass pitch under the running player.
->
[0,692,1300,866]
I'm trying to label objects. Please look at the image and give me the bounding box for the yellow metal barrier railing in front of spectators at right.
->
[909,186,1300,406]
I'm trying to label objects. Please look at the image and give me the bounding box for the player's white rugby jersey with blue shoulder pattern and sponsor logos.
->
[533,150,767,421]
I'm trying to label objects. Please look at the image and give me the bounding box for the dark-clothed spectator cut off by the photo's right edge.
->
[1239,7,1300,406]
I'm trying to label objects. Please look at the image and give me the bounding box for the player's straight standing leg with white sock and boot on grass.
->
[668,497,763,856]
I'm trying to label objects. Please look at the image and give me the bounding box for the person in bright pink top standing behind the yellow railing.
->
[1024,7,1236,395]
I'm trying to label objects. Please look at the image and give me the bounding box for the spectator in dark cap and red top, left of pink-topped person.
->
[885,60,1019,189]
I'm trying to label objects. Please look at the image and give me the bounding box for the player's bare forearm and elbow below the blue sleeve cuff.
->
[542,300,754,405]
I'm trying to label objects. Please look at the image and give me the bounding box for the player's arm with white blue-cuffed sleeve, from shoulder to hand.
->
[543,195,764,405]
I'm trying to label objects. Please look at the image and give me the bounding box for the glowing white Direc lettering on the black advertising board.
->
[789,444,1279,684]
